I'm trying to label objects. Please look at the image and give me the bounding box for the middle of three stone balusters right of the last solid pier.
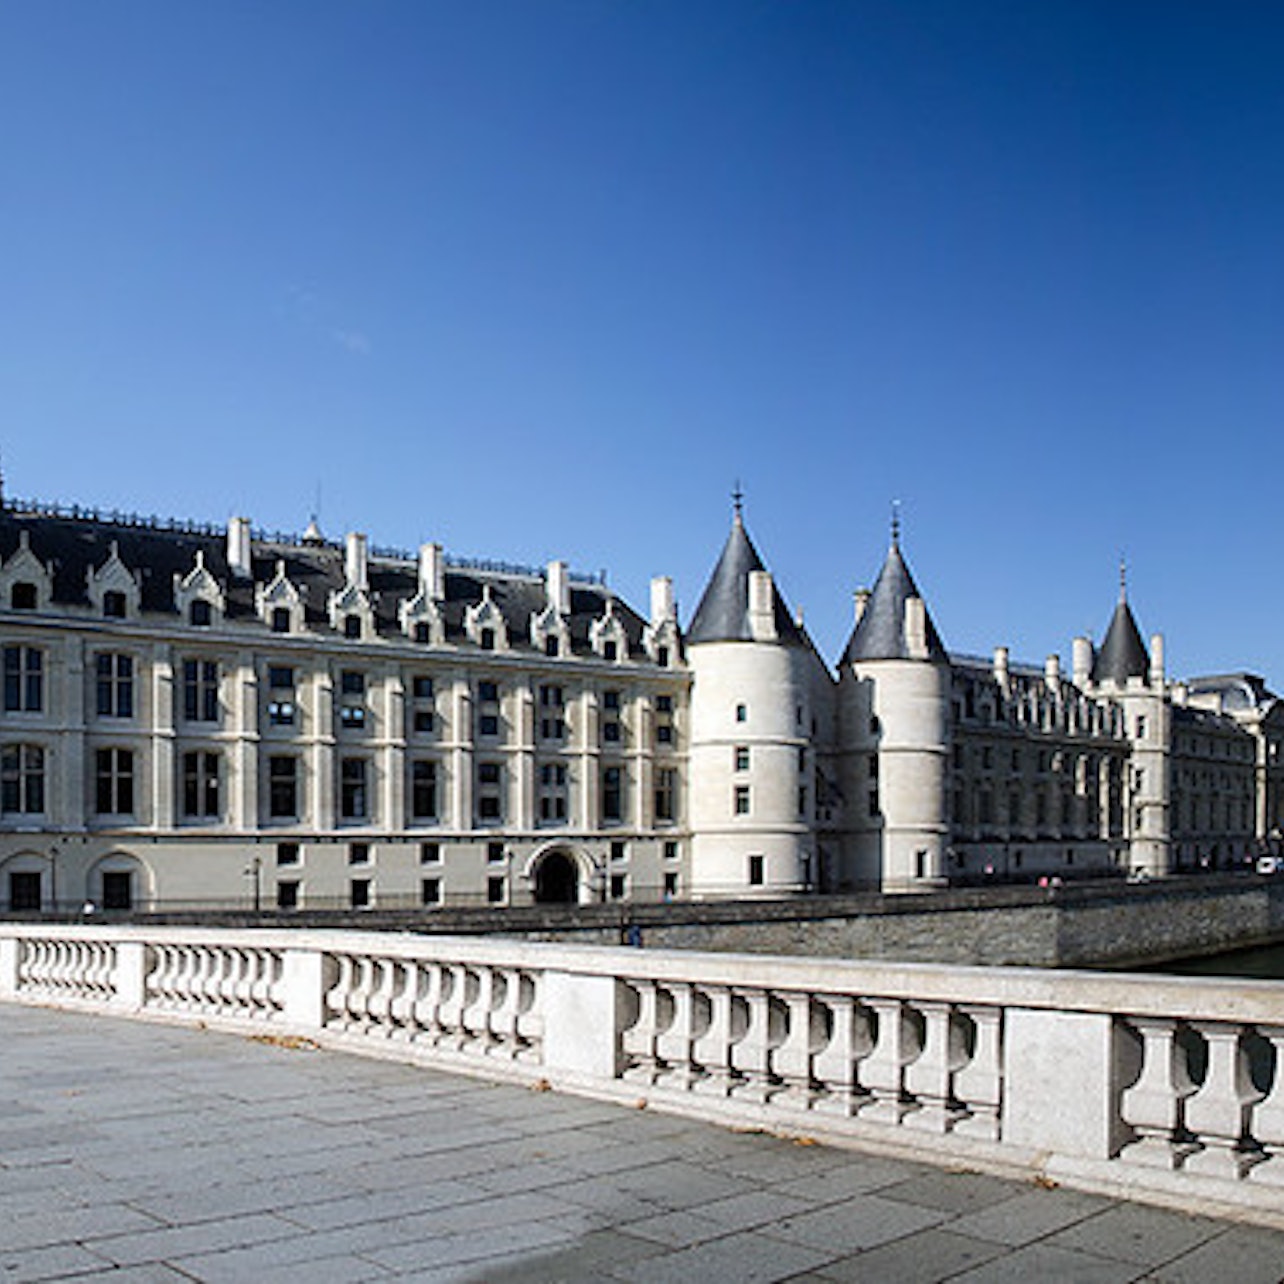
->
[1185,1021,1263,1179]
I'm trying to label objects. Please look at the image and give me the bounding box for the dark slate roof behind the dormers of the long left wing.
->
[0,507,646,655]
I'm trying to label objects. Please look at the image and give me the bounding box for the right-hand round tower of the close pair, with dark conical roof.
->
[838,523,950,891]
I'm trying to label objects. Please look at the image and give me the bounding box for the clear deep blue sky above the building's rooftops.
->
[0,0,1284,687]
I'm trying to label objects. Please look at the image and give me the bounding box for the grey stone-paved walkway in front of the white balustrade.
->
[0,1005,1284,1284]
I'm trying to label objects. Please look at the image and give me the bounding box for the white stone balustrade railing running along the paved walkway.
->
[0,924,1284,1224]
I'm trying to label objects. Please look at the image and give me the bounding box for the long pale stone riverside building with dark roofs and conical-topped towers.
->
[0,482,1284,912]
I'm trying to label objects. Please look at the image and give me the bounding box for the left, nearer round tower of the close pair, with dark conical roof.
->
[686,496,814,899]
